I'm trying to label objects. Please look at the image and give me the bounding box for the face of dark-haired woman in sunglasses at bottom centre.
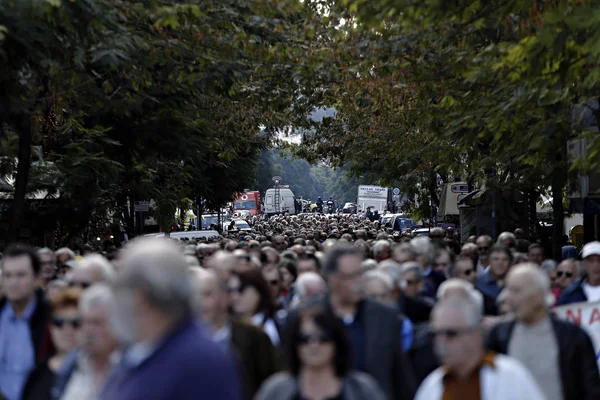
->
[298,318,335,368]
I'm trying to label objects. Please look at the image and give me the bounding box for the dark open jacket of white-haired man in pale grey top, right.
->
[488,317,600,400]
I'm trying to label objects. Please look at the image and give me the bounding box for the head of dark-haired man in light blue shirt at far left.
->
[1,244,41,305]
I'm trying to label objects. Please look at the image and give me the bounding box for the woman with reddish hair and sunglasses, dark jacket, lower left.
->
[22,289,81,400]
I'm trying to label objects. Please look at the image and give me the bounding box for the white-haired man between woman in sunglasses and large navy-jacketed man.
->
[52,284,119,400]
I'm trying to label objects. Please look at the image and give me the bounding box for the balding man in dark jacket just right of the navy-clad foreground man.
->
[194,271,278,400]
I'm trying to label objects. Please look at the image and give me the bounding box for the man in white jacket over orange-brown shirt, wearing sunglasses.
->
[416,295,545,400]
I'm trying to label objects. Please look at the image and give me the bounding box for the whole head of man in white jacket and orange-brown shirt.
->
[431,296,484,376]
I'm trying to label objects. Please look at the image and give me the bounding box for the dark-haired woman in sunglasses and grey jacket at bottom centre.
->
[256,309,385,400]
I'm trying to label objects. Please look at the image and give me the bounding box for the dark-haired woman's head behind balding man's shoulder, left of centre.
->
[228,270,275,317]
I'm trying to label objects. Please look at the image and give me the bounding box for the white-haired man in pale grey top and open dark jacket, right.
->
[489,264,600,400]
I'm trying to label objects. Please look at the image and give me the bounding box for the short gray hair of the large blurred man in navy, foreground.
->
[116,238,194,320]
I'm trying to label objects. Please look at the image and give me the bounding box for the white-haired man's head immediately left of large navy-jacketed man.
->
[79,283,119,359]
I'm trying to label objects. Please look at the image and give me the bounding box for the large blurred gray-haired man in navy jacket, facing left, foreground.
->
[102,239,242,400]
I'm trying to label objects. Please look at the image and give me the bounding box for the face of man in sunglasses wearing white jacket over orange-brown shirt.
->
[432,307,483,368]
